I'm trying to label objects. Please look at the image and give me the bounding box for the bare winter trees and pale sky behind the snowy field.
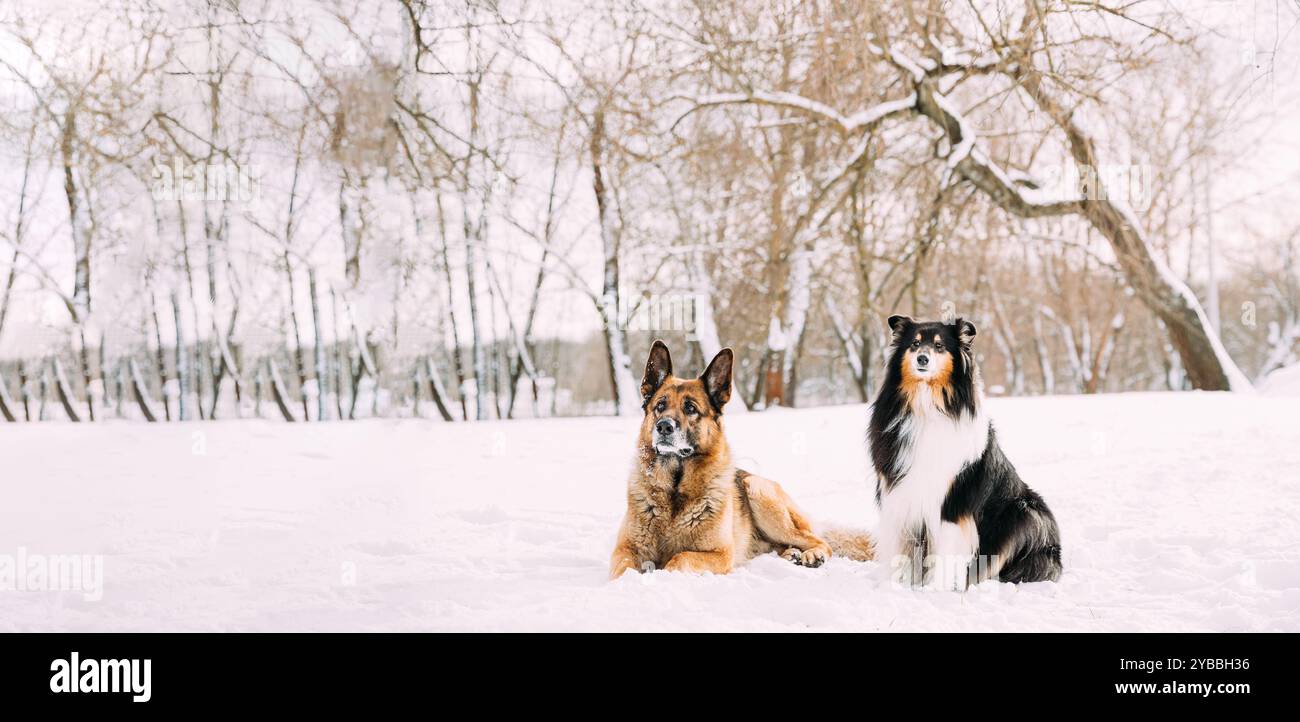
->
[0,0,1300,423]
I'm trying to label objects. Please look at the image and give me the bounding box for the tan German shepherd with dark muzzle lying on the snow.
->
[610,341,872,579]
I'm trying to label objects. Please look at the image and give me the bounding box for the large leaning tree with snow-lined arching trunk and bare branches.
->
[675,0,1251,390]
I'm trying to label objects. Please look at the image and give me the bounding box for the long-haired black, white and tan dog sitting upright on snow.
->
[868,316,1061,589]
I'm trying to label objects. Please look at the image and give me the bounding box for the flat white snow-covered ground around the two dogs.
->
[0,393,1300,631]
